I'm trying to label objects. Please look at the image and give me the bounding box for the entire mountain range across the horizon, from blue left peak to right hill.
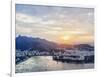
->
[16,35,94,51]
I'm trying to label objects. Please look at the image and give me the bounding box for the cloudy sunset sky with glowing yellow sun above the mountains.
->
[15,4,94,44]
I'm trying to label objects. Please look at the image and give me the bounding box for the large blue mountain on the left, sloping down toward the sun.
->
[16,35,57,51]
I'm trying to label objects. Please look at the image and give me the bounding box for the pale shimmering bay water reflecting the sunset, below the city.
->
[15,56,94,73]
